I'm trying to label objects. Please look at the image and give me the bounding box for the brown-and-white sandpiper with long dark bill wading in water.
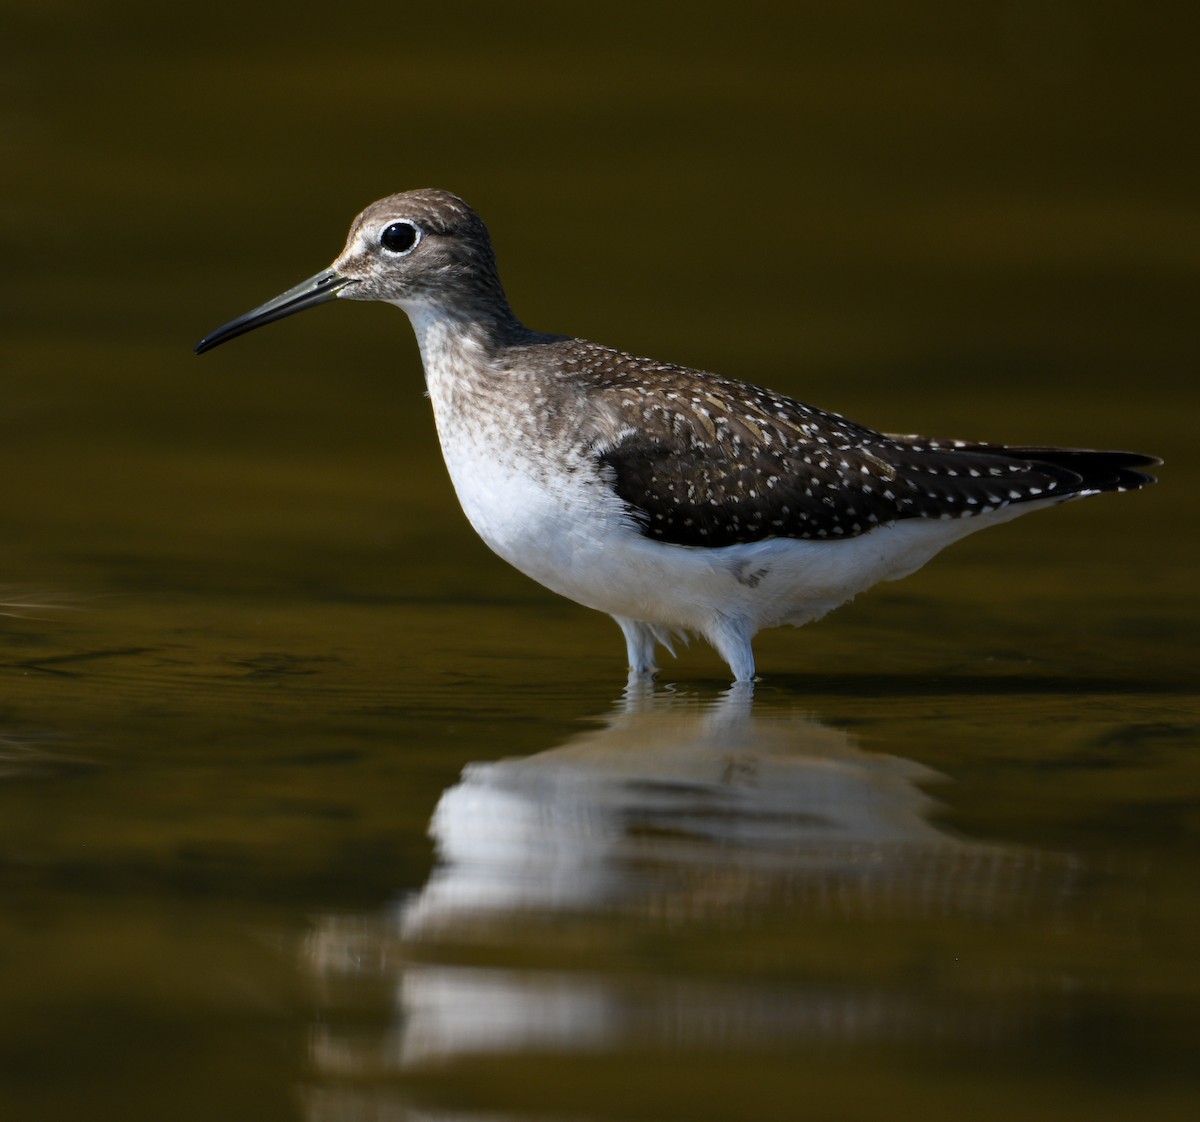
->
[196,190,1158,680]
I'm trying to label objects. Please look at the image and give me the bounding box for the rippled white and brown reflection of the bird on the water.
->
[306,686,1069,1104]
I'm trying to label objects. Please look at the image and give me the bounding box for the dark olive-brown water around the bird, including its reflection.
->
[0,0,1200,1122]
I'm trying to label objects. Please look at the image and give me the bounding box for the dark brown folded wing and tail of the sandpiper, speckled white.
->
[585,356,1156,546]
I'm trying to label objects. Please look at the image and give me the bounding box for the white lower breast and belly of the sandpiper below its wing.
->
[434,420,1044,634]
